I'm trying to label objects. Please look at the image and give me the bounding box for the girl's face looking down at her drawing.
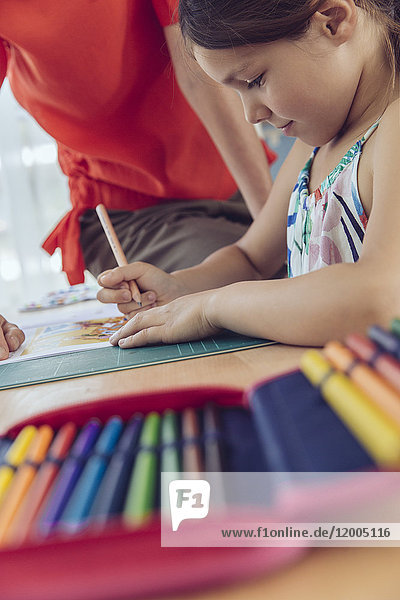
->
[194,21,363,146]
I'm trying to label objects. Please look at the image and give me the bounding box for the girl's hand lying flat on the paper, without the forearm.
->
[110,292,220,348]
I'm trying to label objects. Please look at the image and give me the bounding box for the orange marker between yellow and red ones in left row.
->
[0,425,53,544]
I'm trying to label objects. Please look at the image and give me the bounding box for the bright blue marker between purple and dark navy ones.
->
[59,417,123,533]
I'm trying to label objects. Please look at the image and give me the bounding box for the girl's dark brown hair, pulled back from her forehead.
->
[179,0,400,70]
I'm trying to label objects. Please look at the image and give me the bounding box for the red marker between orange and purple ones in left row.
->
[7,423,76,543]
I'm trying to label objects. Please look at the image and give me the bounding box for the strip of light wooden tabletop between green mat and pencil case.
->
[0,345,303,433]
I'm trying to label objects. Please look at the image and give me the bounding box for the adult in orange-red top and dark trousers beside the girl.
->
[0,0,273,358]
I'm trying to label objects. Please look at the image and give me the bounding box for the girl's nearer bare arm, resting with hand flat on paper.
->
[108,101,400,347]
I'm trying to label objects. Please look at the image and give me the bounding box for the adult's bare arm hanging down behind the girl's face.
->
[164,25,272,218]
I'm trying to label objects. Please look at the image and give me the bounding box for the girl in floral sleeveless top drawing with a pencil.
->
[98,0,400,348]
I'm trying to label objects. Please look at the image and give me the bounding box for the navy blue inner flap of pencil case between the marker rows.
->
[248,372,373,472]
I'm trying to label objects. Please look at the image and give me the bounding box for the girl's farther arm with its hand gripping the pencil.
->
[98,141,311,314]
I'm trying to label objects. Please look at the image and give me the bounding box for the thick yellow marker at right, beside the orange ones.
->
[300,350,400,466]
